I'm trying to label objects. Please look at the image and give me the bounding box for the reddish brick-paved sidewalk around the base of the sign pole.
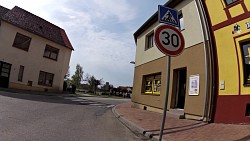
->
[113,102,250,141]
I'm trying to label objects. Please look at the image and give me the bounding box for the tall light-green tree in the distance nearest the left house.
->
[72,64,84,88]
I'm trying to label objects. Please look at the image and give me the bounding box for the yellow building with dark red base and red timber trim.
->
[203,0,250,123]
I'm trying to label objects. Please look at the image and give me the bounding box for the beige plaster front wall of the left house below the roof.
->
[0,21,72,91]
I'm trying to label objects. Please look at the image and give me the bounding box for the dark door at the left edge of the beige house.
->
[0,61,11,88]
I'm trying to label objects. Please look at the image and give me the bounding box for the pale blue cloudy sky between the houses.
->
[0,0,167,87]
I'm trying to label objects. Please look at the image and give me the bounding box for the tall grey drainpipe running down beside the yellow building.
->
[195,0,211,122]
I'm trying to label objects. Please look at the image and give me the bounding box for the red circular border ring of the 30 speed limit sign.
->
[155,25,185,56]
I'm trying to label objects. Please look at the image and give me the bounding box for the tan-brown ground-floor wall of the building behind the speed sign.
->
[132,44,205,116]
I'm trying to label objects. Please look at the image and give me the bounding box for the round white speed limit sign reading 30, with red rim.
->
[155,25,185,56]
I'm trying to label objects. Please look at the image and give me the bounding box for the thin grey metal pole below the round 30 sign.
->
[159,56,171,141]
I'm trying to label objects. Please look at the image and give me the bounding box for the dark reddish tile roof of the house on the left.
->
[0,6,74,50]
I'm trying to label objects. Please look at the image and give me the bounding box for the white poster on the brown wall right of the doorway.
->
[189,75,200,95]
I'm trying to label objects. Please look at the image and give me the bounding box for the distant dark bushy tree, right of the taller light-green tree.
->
[85,73,103,93]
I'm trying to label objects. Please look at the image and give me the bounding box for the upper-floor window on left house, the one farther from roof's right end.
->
[13,33,31,51]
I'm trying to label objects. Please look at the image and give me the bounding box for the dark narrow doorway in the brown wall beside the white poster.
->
[172,68,187,109]
